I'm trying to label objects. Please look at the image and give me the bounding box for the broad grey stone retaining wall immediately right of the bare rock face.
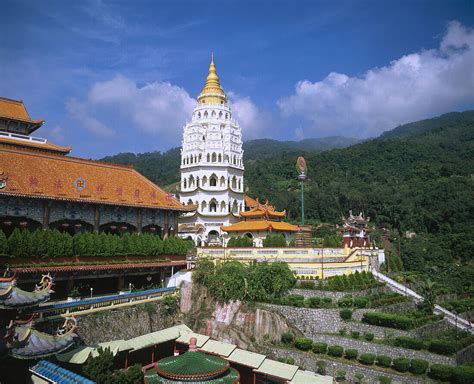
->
[264,304,410,338]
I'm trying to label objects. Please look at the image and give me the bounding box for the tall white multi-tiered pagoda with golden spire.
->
[179,57,245,245]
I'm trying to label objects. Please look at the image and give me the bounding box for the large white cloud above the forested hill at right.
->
[278,22,474,137]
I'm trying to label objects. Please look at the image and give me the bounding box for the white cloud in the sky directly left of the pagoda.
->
[67,75,196,149]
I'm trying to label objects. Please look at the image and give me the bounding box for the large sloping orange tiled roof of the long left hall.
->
[0,147,192,211]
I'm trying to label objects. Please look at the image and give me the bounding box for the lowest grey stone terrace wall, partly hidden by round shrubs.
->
[268,347,432,384]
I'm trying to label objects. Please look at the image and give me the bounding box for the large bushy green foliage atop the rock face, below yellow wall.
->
[193,259,296,302]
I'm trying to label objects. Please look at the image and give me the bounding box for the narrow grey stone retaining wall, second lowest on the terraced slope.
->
[313,335,456,365]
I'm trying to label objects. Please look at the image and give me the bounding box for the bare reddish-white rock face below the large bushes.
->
[181,284,301,350]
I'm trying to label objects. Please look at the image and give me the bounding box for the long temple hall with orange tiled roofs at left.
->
[0,98,192,238]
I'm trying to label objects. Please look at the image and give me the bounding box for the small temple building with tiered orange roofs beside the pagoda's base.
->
[221,198,298,247]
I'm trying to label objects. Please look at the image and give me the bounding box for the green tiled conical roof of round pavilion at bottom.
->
[156,351,229,379]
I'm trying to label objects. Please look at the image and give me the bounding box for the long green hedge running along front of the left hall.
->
[0,228,193,259]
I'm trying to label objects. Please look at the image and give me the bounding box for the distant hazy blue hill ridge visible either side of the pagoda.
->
[101,136,360,186]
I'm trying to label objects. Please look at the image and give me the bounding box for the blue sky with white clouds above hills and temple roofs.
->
[0,0,474,158]
